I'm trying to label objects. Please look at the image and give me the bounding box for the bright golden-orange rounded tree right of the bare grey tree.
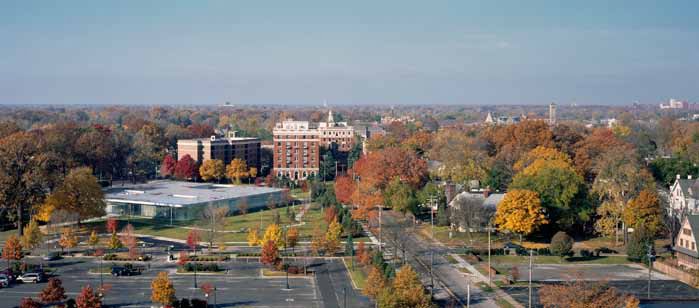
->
[495,189,548,241]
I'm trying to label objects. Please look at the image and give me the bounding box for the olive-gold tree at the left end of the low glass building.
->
[46,167,106,223]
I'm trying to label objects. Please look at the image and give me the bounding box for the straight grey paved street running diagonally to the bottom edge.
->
[383,212,497,307]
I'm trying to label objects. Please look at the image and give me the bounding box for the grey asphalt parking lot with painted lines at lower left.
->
[0,258,371,308]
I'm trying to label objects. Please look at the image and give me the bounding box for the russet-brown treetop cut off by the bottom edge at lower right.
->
[539,279,639,308]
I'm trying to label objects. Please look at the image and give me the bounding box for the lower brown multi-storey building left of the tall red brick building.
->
[177,136,260,170]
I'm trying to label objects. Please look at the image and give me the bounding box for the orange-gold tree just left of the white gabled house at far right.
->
[623,189,663,234]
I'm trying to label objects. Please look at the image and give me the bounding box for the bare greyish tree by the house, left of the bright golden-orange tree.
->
[451,195,495,241]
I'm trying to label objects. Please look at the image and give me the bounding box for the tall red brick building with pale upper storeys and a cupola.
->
[272,111,354,180]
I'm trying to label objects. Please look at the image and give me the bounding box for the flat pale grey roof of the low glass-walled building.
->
[103,180,282,207]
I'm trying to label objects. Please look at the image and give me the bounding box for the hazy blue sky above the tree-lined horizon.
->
[0,0,699,105]
